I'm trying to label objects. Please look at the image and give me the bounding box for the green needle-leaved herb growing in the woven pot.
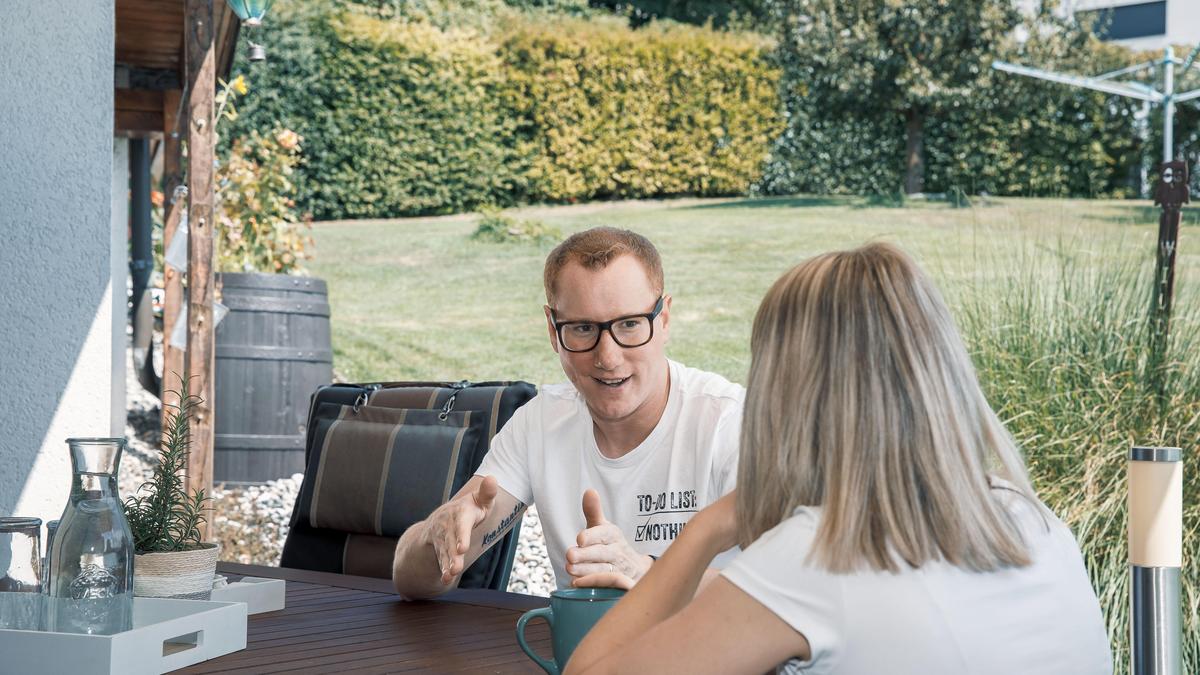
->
[125,381,209,555]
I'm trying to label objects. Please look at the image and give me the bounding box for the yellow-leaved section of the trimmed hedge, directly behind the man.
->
[500,19,779,202]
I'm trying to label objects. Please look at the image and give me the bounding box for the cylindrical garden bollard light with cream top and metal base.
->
[1128,447,1183,675]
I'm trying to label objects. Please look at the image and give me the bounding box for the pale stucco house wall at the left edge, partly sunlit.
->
[0,0,118,520]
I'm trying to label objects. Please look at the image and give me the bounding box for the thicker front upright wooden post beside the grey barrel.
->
[184,0,216,539]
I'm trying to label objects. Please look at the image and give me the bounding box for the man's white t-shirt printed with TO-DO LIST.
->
[475,362,745,589]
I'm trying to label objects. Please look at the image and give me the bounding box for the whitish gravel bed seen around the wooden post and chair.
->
[118,345,554,596]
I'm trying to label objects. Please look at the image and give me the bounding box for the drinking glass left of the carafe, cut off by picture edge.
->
[0,518,42,631]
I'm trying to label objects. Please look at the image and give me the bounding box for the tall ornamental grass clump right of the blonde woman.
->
[956,241,1200,674]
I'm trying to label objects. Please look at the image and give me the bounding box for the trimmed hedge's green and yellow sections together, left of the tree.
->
[233,2,780,220]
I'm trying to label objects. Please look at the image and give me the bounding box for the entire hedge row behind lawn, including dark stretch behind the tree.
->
[236,0,1200,211]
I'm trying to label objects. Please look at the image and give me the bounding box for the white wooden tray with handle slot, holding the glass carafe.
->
[0,598,247,675]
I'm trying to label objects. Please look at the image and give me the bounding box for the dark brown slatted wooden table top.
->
[179,562,551,673]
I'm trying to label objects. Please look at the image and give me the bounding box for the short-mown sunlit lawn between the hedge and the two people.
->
[311,192,1196,383]
